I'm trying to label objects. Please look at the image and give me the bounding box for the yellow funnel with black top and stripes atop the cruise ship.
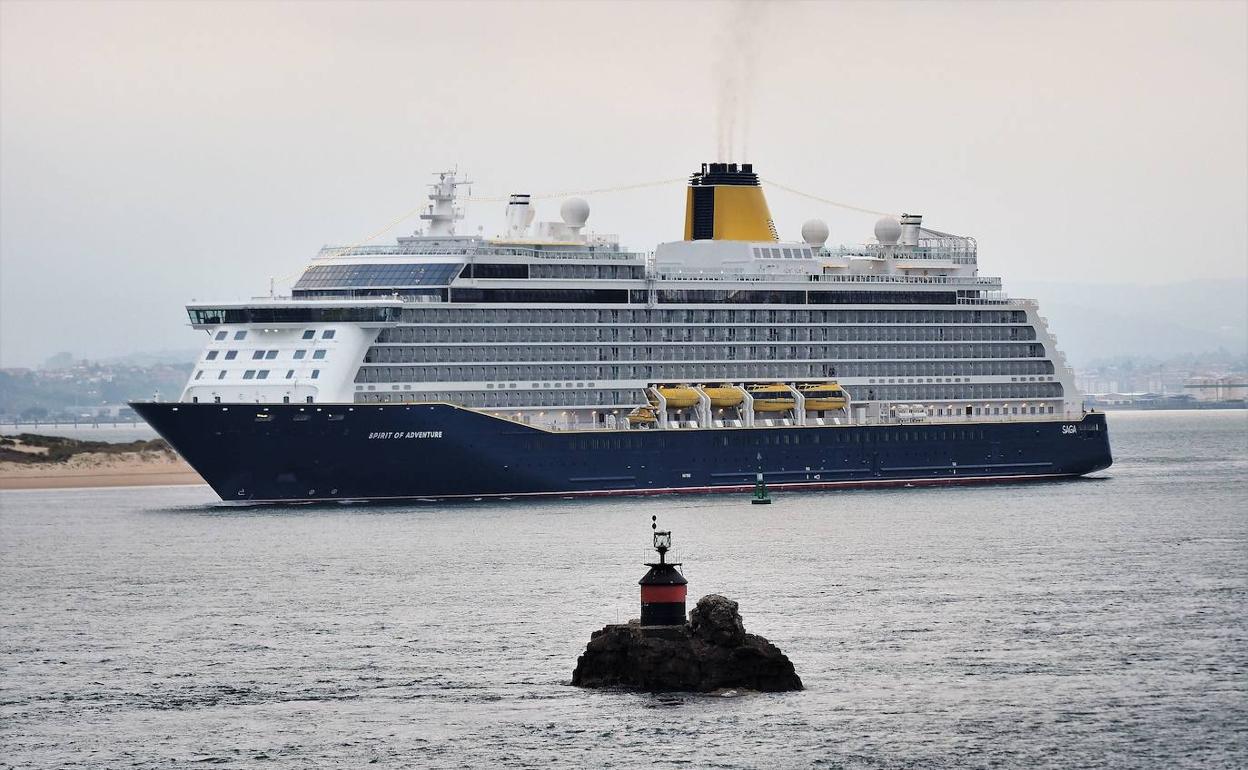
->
[685,163,780,241]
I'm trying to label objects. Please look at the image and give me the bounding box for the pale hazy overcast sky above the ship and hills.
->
[0,0,1248,366]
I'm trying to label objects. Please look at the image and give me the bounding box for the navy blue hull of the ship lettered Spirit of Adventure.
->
[131,403,1112,502]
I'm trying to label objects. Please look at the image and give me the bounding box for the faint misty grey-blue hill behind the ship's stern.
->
[1006,281,1248,367]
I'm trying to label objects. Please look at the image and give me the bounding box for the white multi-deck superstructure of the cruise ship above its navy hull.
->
[181,165,1082,429]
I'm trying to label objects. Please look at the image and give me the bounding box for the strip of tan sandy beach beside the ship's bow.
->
[0,452,205,489]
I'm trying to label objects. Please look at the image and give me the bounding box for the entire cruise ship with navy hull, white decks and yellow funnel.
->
[132,162,1111,502]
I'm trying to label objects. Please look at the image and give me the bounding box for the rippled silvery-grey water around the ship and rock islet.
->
[0,412,1248,769]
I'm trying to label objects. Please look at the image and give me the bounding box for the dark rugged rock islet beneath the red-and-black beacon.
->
[572,594,801,693]
